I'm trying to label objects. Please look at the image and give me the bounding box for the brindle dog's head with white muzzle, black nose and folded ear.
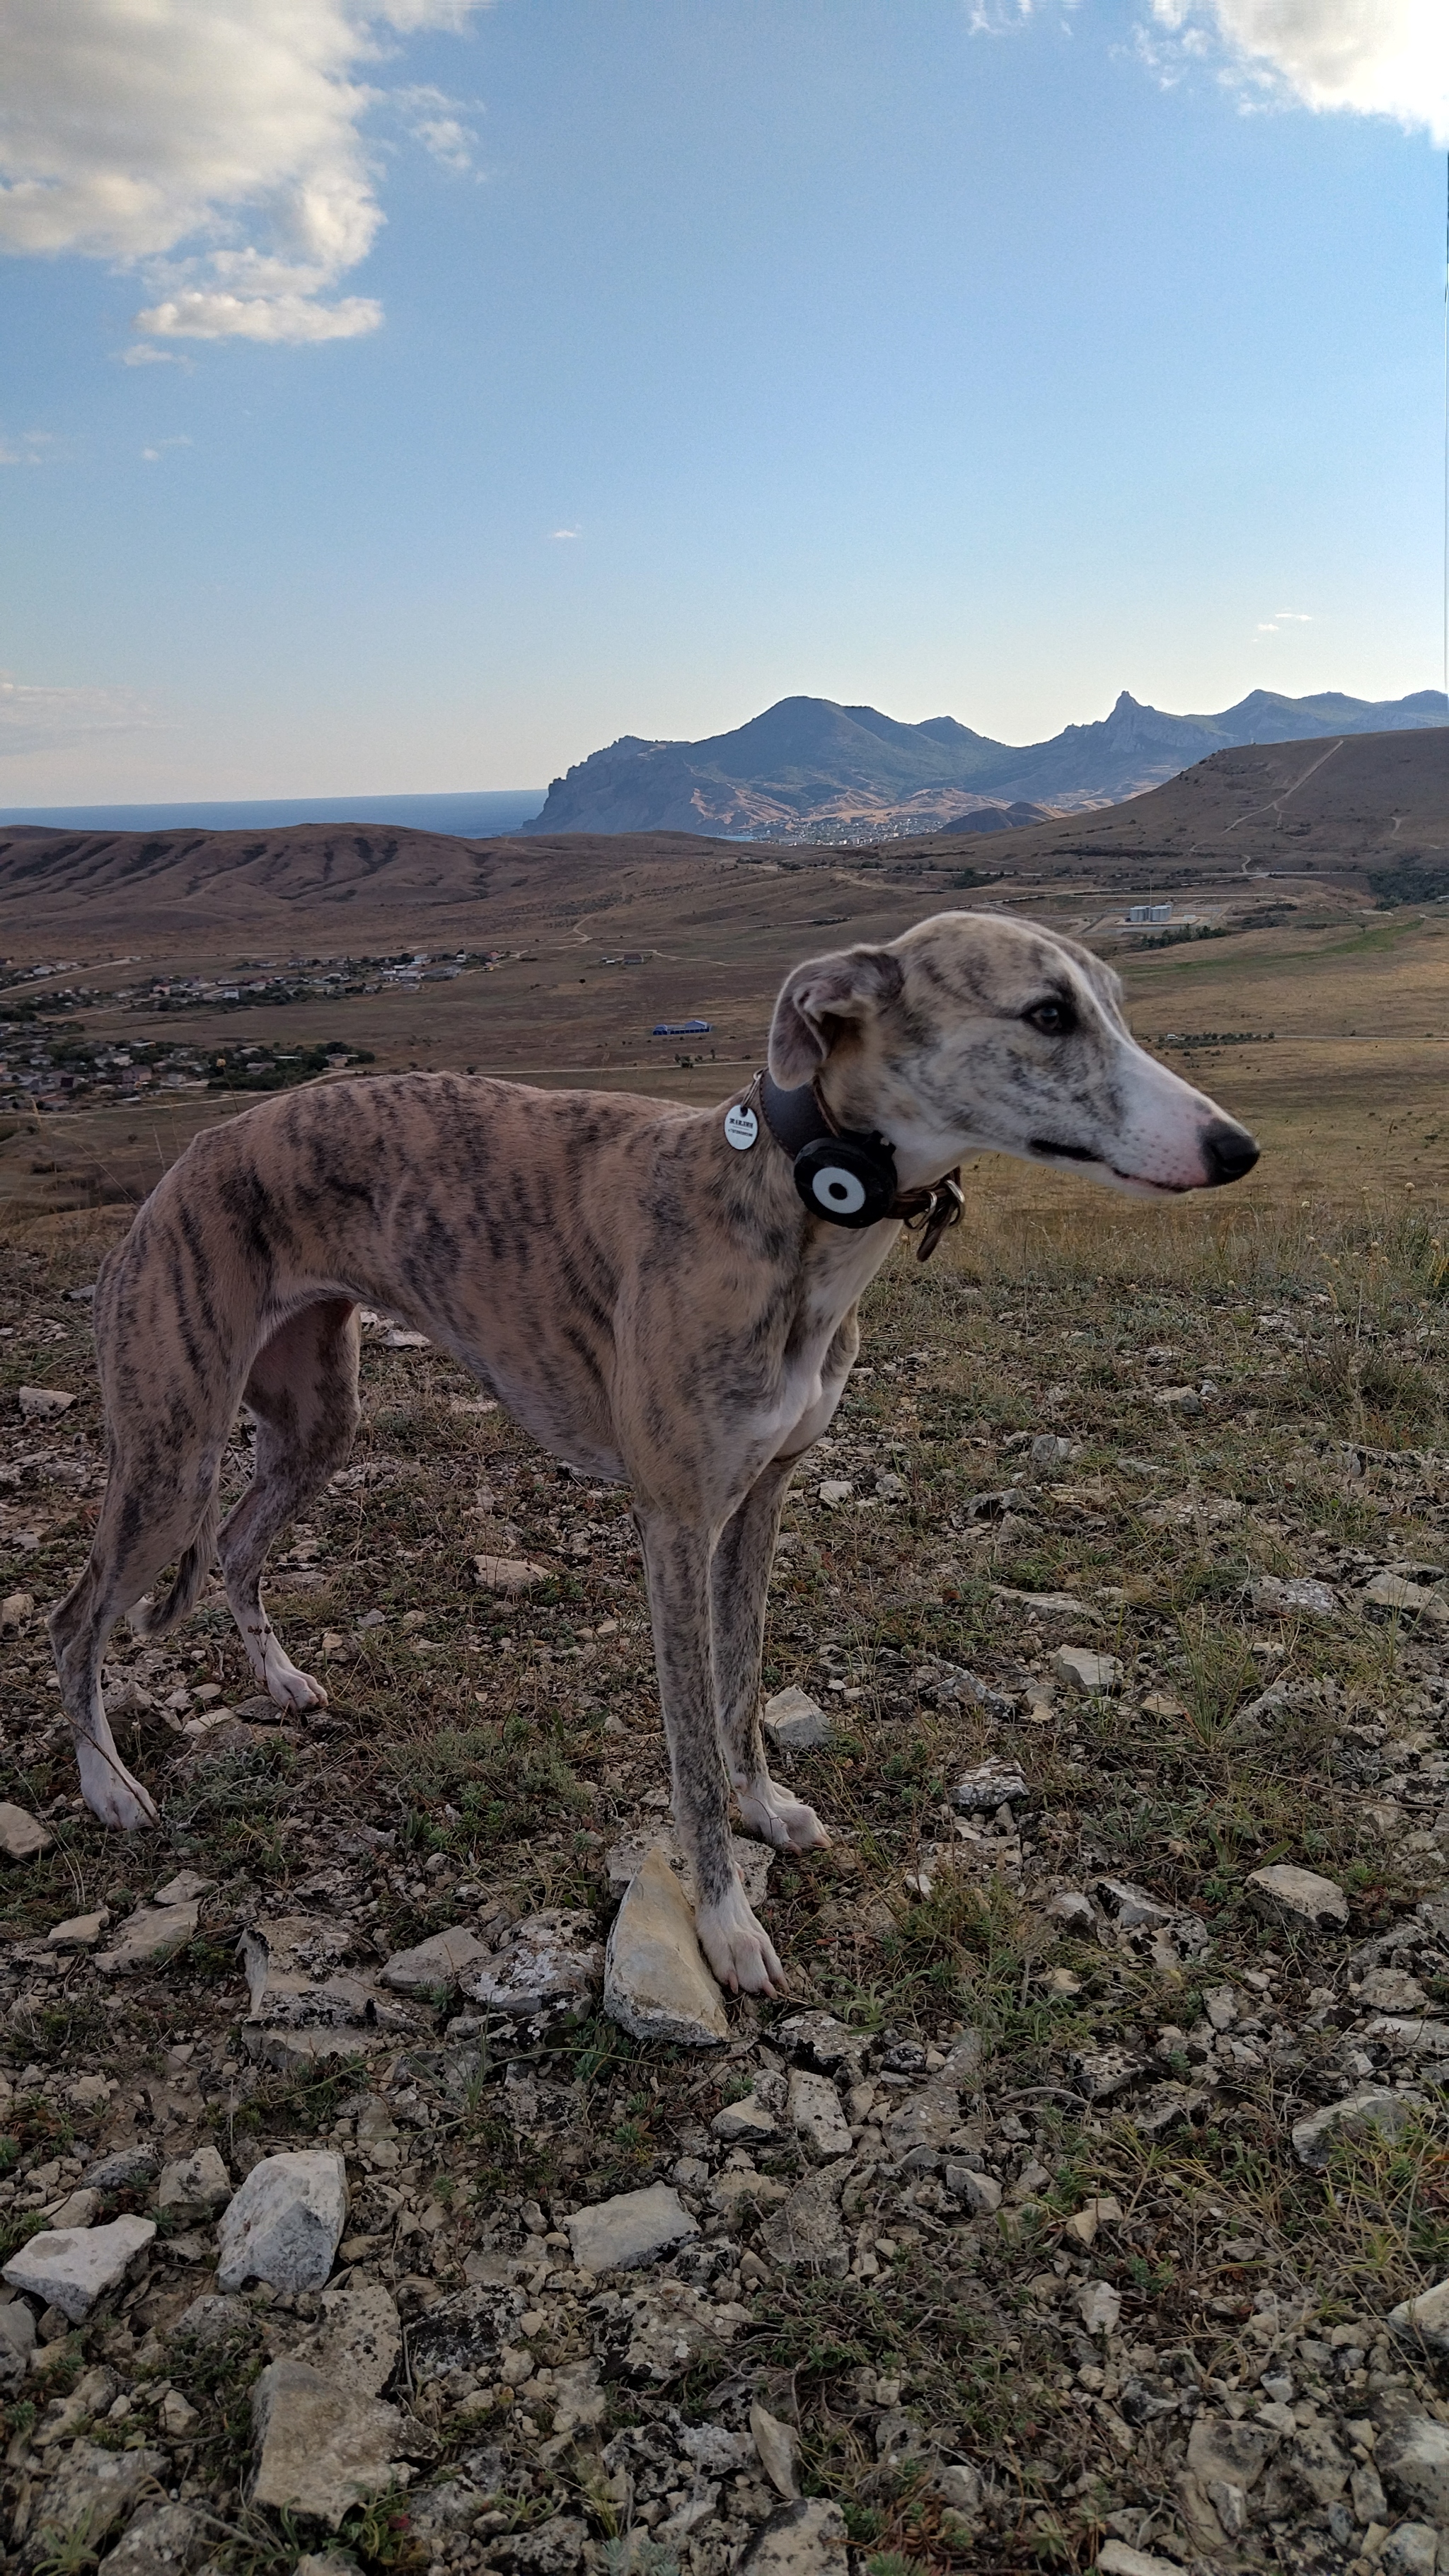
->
[768,912,1258,1198]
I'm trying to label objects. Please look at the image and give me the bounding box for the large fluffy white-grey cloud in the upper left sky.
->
[0,0,487,347]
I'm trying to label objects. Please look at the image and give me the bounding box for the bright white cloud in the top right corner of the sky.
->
[1137,0,1449,147]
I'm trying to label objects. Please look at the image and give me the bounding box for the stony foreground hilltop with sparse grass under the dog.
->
[0,1190,1449,2576]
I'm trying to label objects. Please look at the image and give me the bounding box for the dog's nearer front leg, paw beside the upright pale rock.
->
[634,1507,784,1994]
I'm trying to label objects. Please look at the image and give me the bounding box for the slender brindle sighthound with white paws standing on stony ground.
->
[52,912,1258,1994]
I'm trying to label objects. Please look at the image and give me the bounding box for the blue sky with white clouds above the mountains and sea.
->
[0,0,1449,807]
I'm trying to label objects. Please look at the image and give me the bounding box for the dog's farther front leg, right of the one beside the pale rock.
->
[712,1458,830,1852]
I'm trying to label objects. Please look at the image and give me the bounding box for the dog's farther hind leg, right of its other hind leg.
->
[217,1298,361,1708]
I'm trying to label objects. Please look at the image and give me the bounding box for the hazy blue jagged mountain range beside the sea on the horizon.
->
[524,688,1449,843]
